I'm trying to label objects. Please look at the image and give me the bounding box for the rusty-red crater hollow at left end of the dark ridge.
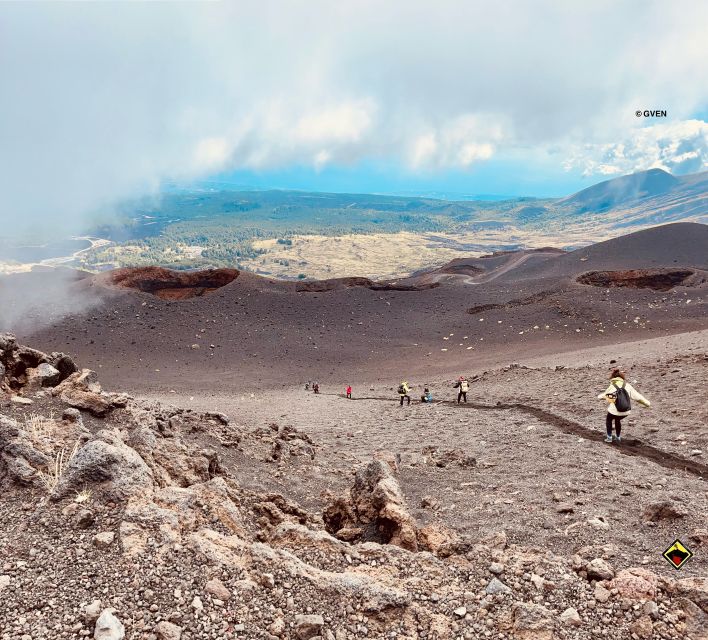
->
[110,267,240,300]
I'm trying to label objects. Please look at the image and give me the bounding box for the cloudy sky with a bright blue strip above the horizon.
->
[0,0,708,236]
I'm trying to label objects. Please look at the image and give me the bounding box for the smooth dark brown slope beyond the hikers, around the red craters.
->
[4,225,707,394]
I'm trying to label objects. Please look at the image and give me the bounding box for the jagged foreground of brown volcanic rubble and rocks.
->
[0,335,708,640]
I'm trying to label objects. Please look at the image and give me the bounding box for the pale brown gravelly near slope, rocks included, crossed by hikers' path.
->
[0,334,708,640]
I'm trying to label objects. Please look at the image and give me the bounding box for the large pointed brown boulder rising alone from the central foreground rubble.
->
[322,460,418,551]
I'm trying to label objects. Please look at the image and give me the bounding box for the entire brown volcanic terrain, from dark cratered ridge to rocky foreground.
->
[0,223,708,640]
